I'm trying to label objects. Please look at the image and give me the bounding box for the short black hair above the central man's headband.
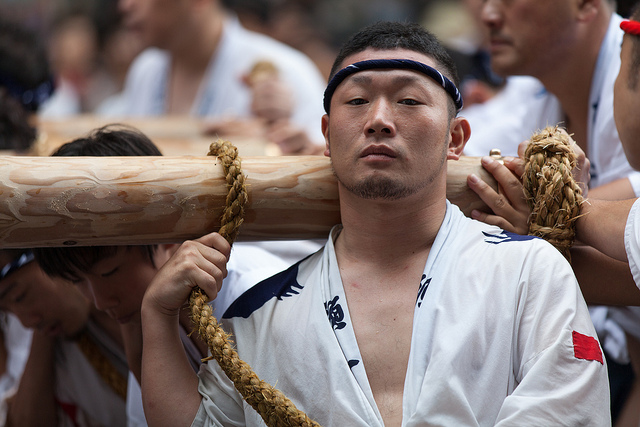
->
[329,21,460,86]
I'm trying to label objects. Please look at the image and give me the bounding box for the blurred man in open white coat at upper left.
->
[119,0,324,154]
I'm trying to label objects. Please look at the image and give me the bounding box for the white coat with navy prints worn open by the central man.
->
[193,203,611,426]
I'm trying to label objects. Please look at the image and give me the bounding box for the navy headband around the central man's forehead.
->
[324,59,462,114]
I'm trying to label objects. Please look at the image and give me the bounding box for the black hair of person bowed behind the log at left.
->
[33,125,162,281]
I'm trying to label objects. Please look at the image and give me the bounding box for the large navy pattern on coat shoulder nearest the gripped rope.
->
[222,262,302,319]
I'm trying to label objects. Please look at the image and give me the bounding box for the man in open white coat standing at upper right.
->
[462,0,640,420]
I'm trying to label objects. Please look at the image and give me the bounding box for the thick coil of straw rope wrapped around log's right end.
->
[522,126,583,260]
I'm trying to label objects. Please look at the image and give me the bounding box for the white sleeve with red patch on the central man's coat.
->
[496,249,611,426]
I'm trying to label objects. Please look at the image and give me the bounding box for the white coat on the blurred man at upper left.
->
[117,17,326,145]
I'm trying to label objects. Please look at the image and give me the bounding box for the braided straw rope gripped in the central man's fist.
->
[189,140,318,427]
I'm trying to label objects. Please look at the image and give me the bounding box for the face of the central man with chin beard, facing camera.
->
[322,49,457,200]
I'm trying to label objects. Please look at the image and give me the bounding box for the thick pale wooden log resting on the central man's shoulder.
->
[0,156,496,248]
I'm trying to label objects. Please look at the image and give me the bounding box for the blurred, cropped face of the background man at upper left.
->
[118,0,189,49]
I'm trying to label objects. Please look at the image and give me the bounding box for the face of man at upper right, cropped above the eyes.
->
[481,0,574,78]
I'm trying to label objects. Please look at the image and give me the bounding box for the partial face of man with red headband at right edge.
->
[613,35,640,169]
